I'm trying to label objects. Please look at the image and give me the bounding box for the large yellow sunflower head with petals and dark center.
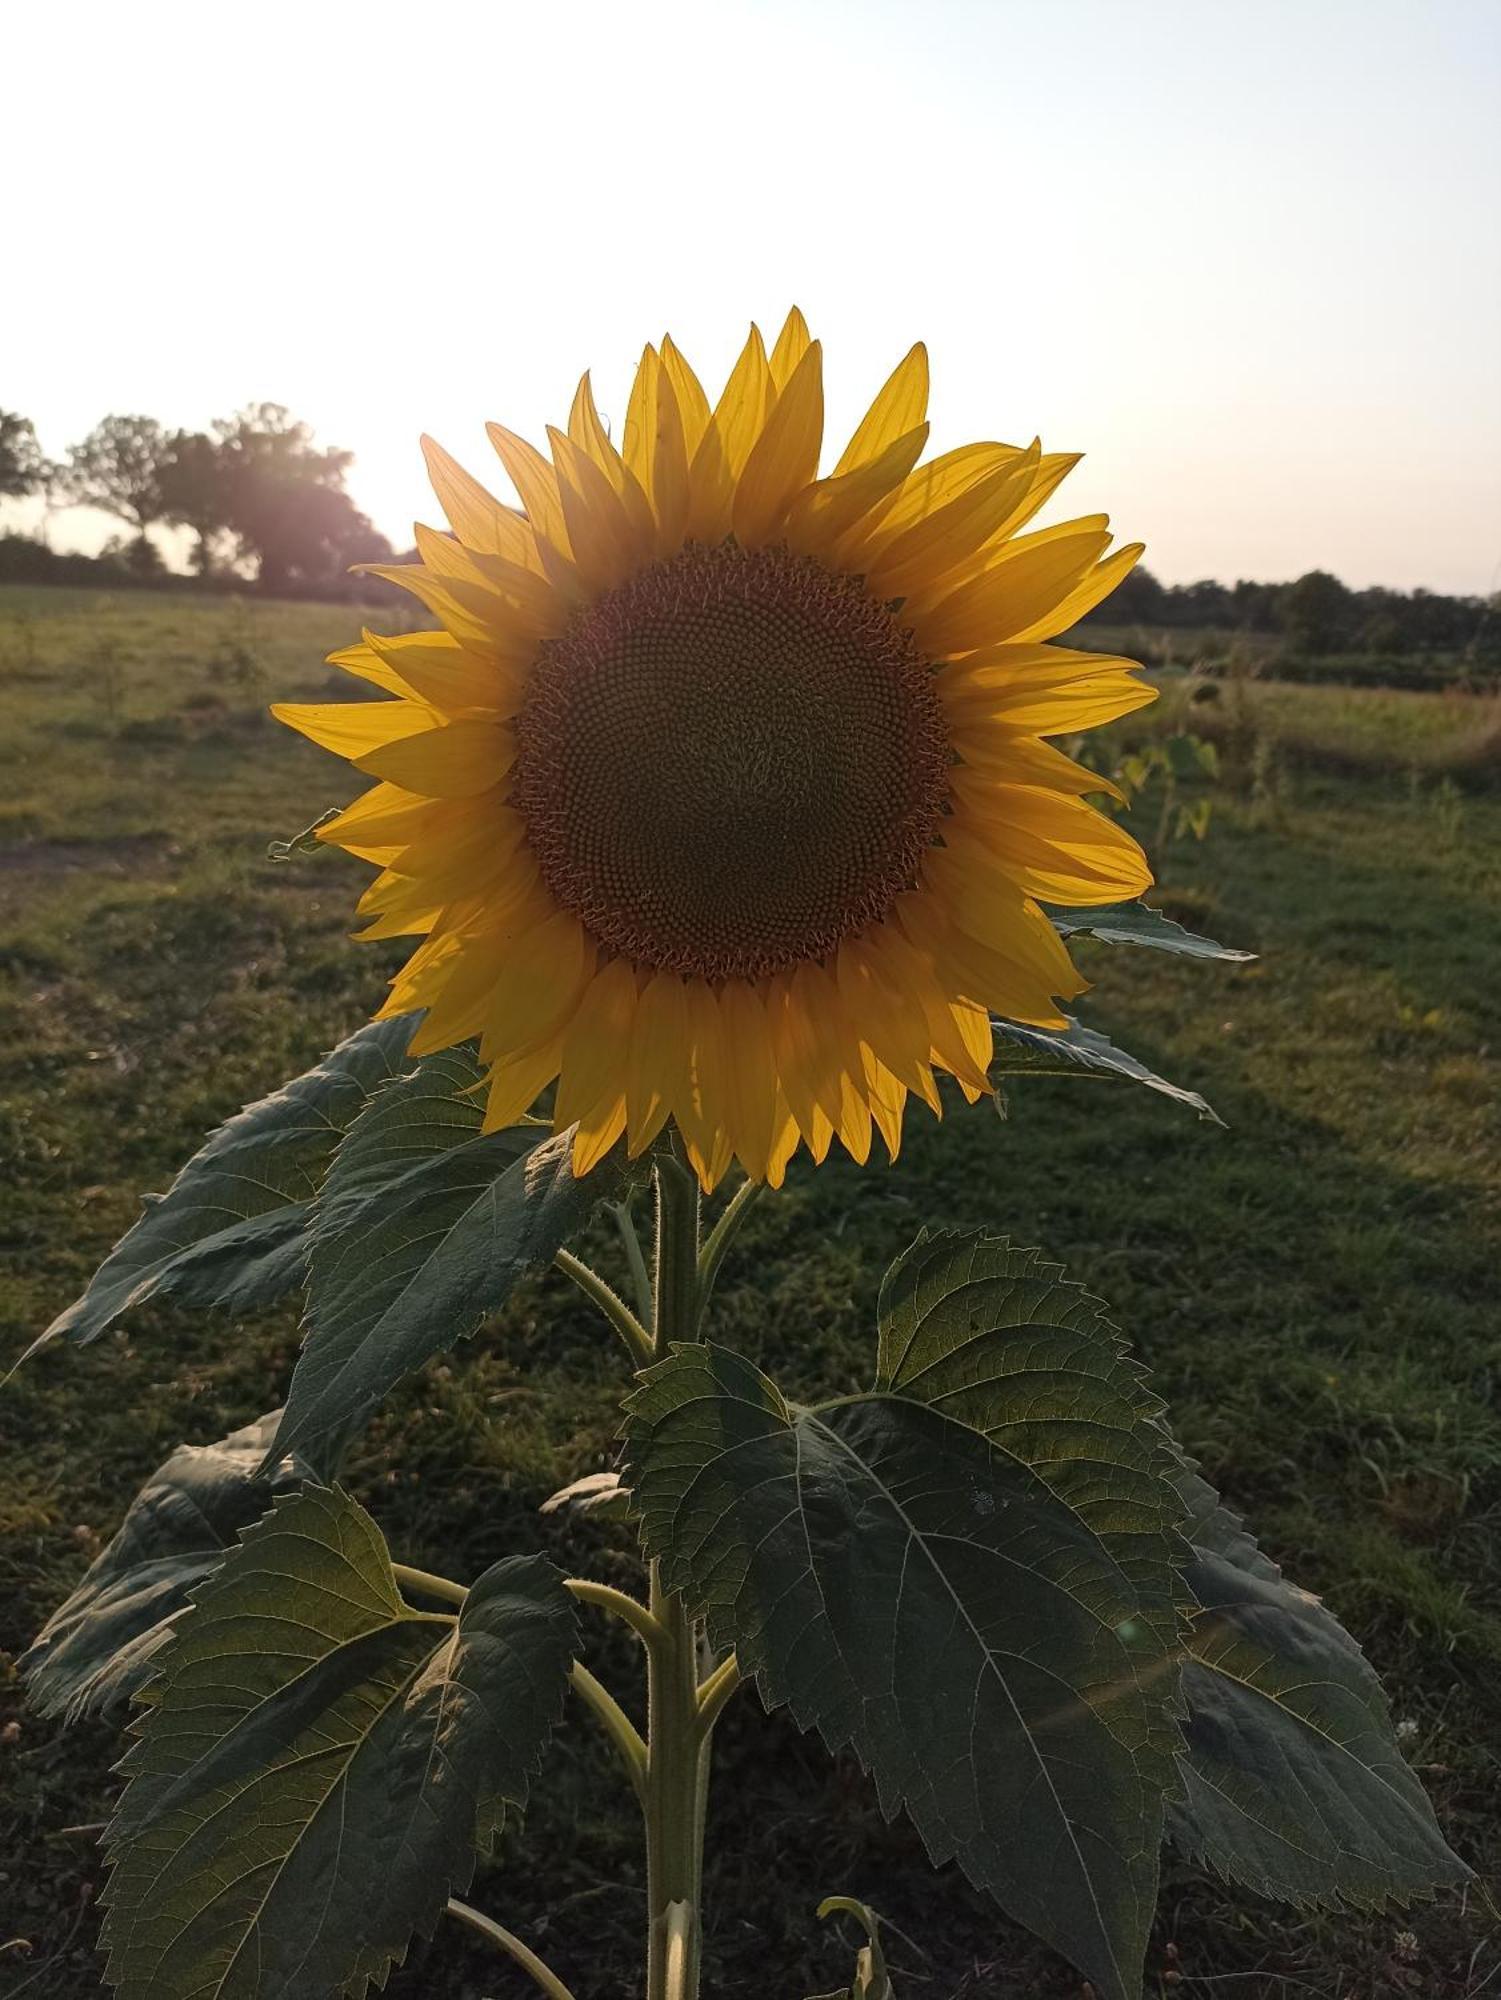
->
[274,310,1151,1190]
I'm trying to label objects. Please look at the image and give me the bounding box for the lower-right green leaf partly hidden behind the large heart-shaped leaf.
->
[1169,1474,1469,1908]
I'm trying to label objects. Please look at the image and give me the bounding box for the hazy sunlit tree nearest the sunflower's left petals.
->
[214,402,390,592]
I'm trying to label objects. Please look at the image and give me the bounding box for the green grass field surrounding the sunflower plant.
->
[0,590,1501,2000]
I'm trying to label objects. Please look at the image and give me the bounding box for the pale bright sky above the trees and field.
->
[0,0,1501,592]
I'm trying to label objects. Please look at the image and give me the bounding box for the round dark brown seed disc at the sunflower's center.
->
[512,542,949,980]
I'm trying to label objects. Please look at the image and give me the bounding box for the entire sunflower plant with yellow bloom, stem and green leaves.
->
[24,312,1465,2000]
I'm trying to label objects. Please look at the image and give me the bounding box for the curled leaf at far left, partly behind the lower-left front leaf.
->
[20,1410,316,1722]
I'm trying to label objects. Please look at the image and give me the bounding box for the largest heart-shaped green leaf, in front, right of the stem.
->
[626,1236,1183,2000]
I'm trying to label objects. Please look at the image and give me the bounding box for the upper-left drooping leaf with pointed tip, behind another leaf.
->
[28,1014,424,1354]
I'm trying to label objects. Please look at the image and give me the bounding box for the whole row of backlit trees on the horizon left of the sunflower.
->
[0,402,390,596]
